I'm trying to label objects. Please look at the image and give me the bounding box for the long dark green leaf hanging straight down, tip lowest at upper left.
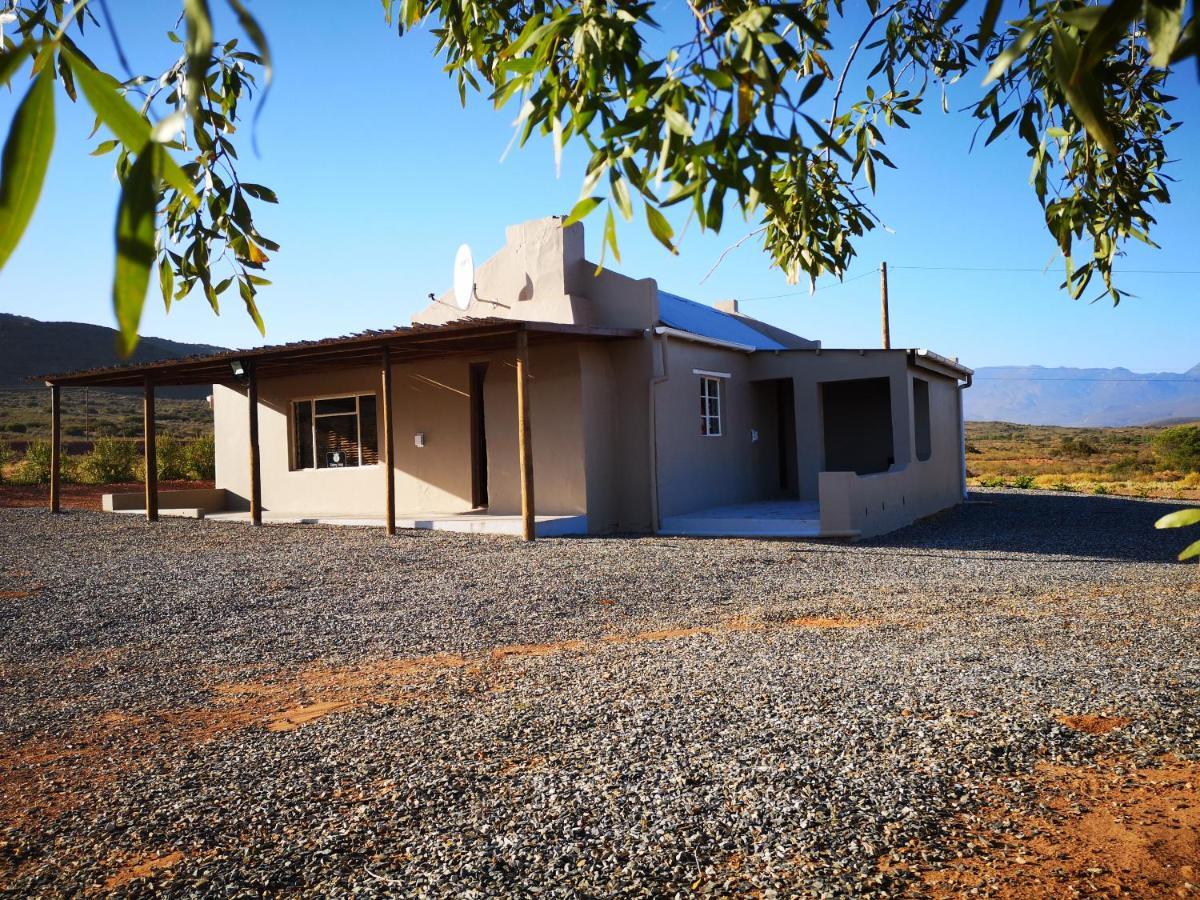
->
[113,140,166,356]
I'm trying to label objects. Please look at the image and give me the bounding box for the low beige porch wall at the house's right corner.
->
[818,462,961,538]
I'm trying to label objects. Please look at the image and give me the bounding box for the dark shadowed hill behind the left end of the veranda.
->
[0,313,226,397]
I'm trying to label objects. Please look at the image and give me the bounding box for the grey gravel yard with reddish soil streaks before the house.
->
[0,492,1200,896]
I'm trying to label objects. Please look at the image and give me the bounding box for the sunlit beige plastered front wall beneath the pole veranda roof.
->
[214,340,650,533]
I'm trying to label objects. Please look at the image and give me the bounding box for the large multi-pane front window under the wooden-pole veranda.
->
[292,394,379,469]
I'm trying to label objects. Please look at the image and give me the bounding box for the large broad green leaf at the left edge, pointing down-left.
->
[0,67,54,269]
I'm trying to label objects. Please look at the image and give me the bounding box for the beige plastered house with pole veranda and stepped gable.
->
[46,217,971,538]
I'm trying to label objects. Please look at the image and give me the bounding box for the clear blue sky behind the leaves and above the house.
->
[0,0,1200,371]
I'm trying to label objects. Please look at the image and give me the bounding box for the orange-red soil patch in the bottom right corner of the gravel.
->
[914,758,1200,900]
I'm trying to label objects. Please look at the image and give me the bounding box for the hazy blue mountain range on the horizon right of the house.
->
[964,365,1200,426]
